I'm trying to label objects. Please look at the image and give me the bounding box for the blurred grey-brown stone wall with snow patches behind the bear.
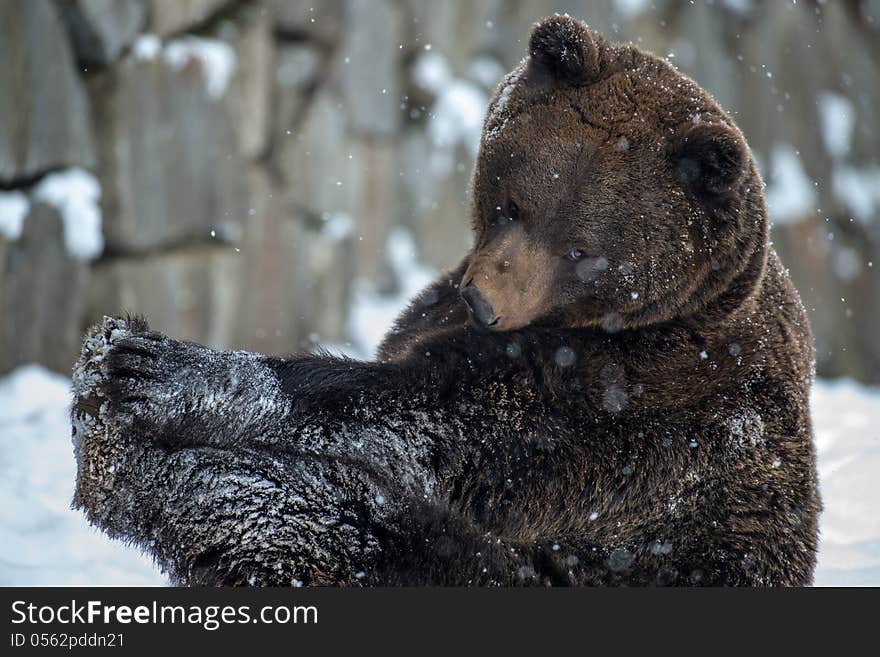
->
[0,0,880,382]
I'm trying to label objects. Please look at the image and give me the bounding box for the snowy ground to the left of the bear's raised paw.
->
[0,365,166,586]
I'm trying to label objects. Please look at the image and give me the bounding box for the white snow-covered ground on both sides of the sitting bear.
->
[0,358,880,586]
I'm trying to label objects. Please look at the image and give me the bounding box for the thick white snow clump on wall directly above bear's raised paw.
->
[31,167,104,260]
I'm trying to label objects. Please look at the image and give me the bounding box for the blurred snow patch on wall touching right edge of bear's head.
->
[765,144,816,224]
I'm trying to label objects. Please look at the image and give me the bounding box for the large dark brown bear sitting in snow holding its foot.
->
[73,16,820,585]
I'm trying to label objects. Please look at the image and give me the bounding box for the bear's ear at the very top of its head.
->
[529,15,601,85]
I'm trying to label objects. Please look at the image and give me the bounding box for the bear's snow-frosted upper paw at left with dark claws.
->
[78,317,290,446]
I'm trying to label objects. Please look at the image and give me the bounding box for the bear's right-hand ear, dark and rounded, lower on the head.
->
[673,123,748,201]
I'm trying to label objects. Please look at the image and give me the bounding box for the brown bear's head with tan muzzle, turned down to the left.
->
[460,16,767,332]
